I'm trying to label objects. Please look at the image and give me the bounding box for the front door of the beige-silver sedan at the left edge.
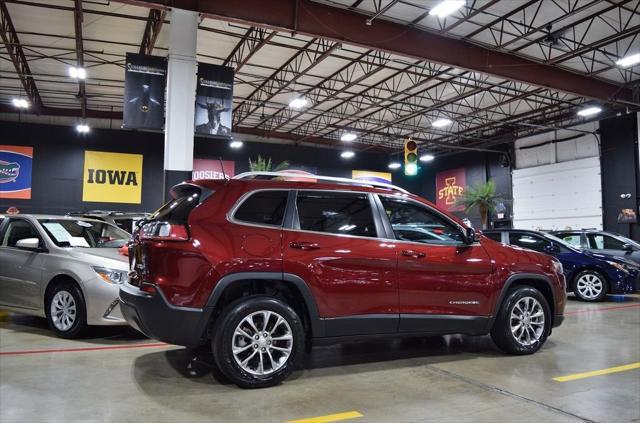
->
[0,218,46,309]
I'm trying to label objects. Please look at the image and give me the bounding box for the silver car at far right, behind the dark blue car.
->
[551,229,640,265]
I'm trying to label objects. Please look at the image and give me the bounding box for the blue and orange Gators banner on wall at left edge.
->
[0,145,33,200]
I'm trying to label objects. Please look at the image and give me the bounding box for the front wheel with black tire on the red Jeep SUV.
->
[491,286,551,355]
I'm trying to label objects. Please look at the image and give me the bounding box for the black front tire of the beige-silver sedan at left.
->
[45,282,87,339]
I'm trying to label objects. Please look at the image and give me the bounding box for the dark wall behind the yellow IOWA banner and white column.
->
[0,122,388,214]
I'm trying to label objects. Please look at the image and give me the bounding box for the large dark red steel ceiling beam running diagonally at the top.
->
[119,0,640,106]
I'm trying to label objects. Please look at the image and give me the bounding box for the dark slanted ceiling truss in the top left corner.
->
[0,1,43,113]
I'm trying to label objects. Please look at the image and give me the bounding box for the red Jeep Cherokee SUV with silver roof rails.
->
[120,173,566,387]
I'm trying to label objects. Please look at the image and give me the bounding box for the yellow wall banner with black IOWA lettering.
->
[82,151,142,204]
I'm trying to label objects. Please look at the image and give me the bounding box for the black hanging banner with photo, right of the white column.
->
[195,63,233,138]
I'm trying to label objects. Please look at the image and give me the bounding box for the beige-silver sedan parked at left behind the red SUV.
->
[0,214,129,338]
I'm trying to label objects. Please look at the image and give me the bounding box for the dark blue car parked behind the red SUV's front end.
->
[483,229,640,301]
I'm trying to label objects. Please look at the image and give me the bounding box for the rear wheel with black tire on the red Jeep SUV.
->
[211,295,305,388]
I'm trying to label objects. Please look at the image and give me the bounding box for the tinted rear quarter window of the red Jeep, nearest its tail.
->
[233,191,288,226]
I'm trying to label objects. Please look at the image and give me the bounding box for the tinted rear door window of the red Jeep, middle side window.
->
[296,192,377,237]
